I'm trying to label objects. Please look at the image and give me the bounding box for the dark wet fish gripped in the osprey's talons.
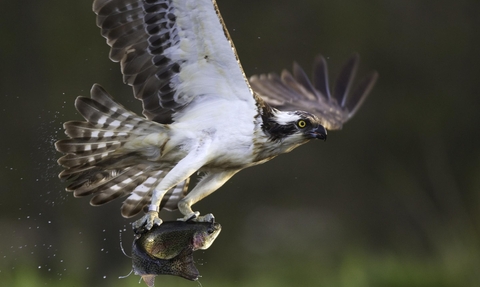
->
[132,221,222,287]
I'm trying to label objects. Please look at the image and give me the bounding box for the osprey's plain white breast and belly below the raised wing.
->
[170,96,257,167]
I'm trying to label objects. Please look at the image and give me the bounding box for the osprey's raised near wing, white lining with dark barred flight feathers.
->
[93,0,255,123]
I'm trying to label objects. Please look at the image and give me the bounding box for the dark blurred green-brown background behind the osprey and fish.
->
[0,0,480,287]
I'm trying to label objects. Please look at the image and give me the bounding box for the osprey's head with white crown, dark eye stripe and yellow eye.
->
[263,110,327,144]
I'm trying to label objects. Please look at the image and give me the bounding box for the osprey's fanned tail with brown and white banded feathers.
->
[55,85,182,217]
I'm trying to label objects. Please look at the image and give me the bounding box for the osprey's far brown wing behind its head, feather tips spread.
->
[250,54,378,130]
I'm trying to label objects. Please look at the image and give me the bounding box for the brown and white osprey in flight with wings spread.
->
[55,0,377,229]
